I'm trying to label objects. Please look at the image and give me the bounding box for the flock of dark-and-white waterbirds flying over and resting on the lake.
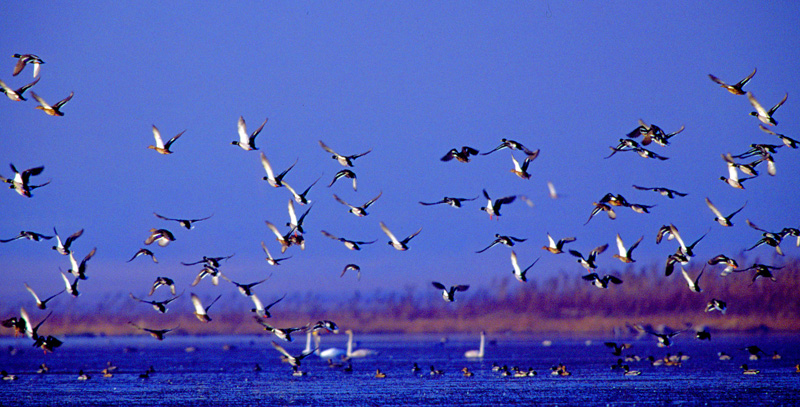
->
[0,54,800,377]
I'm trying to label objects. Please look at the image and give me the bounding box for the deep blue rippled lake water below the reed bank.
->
[0,334,800,406]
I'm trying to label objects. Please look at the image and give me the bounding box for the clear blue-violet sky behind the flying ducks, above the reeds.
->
[0,1,800,310]
